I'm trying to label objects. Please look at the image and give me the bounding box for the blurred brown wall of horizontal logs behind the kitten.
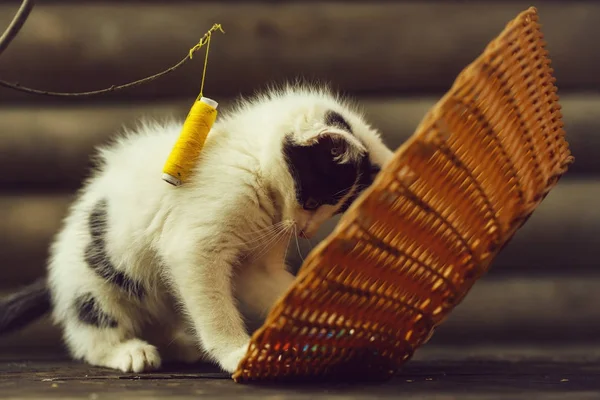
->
[0,0,600,347]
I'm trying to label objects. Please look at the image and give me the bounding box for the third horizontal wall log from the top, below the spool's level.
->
[0,179,600,288]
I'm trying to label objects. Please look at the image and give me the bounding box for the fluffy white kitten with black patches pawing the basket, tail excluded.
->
[0,86,392,372]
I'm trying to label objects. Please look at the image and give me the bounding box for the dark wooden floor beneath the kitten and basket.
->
[0,346,600,400]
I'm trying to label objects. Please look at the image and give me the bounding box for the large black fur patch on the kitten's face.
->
[283,136,372,213]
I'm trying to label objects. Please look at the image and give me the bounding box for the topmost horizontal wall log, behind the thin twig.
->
[0,1,600,101]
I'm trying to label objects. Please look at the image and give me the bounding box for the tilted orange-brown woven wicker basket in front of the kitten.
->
[233,8,573,382]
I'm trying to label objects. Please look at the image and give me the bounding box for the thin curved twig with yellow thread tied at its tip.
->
[0,24,225,97]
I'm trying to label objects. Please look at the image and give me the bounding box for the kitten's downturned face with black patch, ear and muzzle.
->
[282,109,380,237]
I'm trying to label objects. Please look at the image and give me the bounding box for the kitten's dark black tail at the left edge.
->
[0,278,51,335]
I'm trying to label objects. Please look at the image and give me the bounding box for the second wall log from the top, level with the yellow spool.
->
[0,95,600,191]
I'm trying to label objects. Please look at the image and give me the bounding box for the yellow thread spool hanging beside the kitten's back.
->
[162,97,218,186]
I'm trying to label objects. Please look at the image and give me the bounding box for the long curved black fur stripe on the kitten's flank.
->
[85,200,145,297]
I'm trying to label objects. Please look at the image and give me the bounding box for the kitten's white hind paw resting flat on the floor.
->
[109,339,160,372]
